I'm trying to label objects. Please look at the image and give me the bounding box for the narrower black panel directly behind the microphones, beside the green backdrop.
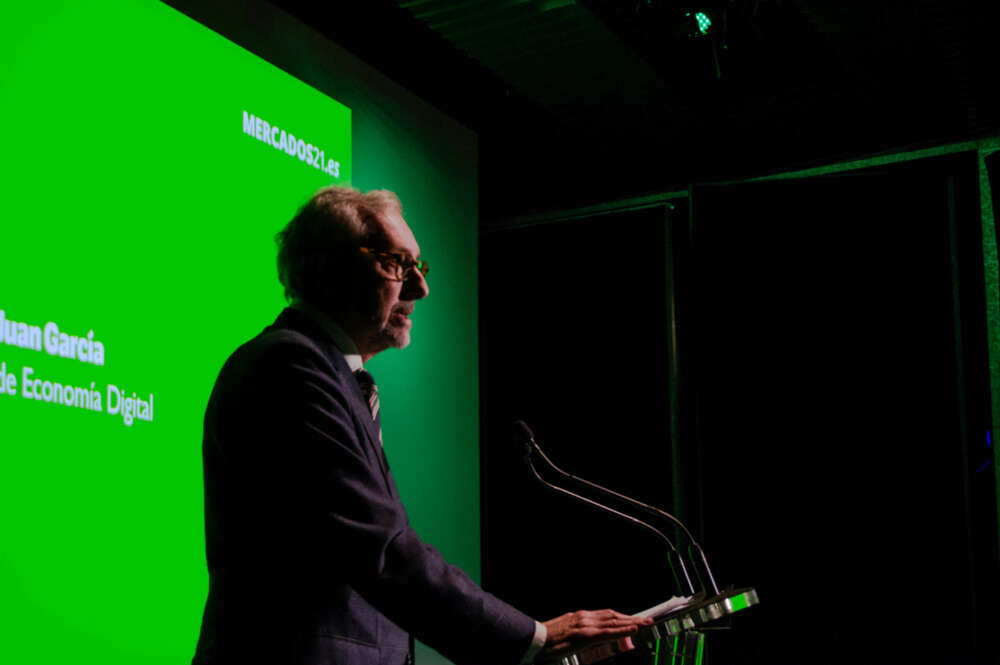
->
[480,206,686,619]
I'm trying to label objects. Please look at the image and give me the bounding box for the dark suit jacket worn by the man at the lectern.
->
[194,309,535,665]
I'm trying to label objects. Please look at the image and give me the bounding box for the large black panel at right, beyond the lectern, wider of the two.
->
[685,153,997,663]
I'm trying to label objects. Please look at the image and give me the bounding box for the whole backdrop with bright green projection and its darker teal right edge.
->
[0,0,479,665]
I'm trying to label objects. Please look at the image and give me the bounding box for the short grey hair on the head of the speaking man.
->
[274,185,403,306]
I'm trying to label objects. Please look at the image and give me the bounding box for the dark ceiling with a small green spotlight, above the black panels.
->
[273,0,1000,219]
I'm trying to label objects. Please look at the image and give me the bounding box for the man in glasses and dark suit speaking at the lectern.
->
[194,187,648,665]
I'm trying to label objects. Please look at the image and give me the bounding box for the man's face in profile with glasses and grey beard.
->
[354,211,429,360]
